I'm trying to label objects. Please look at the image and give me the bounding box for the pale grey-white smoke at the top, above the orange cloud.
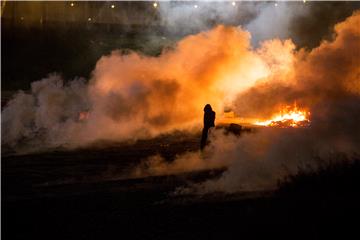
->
[159,1,309,46]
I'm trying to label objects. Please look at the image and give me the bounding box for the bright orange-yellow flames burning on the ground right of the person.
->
[254,104,310,127]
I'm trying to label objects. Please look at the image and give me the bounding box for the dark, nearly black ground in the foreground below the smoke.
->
[2,133,360,239]
